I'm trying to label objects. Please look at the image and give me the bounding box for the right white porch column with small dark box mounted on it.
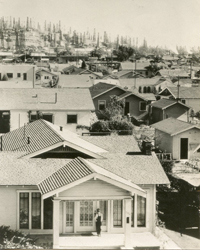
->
[124,198,133,249]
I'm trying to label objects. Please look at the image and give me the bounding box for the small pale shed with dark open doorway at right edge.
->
[151,117,200,160]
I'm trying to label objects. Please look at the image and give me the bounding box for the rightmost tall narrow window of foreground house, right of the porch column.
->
[137,196,146,227]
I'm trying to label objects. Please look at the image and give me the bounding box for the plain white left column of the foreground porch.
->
[53,200,60,249]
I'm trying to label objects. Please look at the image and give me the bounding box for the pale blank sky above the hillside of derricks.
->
[0,0,200,51]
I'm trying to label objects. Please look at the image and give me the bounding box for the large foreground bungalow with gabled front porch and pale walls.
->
[0,120,169,249]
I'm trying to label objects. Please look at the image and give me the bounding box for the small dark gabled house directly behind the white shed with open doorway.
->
[149,99,191,123]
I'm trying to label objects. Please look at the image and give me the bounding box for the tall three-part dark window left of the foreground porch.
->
[19,191,53,230]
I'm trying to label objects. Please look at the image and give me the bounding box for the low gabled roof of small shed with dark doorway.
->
[151,117,200,136]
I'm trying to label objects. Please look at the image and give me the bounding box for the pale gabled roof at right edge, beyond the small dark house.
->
[159,87,200,99]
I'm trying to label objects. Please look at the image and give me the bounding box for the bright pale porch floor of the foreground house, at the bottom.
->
[59,232,161,249]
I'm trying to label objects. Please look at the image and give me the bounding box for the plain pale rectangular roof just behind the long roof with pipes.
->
[58,75,93,88]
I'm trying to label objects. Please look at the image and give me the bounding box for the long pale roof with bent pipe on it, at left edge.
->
[0,88,94,111]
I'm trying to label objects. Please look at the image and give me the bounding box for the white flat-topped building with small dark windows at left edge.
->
[0,64,35,81]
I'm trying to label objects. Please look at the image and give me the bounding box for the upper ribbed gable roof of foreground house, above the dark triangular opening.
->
[1,119,106,158]
